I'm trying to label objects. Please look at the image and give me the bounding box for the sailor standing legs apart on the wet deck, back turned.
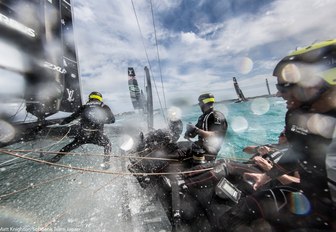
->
[50,92,115,169]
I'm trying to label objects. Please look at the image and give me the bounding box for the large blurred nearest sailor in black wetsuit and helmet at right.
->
[216,40,336,232]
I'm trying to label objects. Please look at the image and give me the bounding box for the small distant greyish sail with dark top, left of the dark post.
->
[128,67,144,110]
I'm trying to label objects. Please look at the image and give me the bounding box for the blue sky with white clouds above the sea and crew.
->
[72,0,336,113]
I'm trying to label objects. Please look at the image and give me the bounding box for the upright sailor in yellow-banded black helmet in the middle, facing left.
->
[182,93,228,165]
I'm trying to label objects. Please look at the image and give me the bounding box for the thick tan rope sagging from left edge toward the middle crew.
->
[4,152,213,176]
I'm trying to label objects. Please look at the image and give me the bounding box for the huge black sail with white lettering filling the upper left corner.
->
[0,0,82,145]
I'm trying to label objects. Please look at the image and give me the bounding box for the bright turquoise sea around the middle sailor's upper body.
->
[176,97,287,158]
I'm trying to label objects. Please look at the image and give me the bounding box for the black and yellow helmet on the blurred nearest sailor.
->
[273,39,336,93]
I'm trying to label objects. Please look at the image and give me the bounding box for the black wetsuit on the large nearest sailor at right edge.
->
[217,108,336,231]
